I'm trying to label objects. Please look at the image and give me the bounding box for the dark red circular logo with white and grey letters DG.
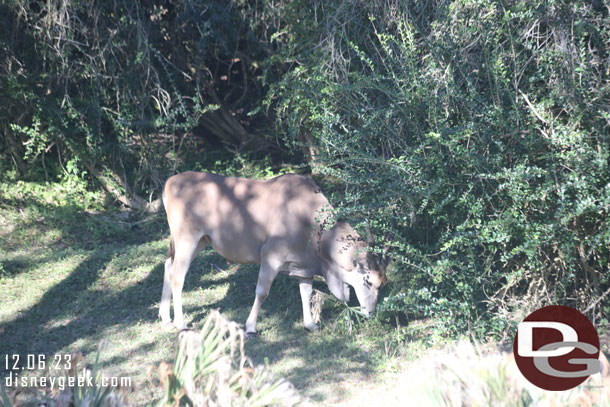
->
[513,305,600,391]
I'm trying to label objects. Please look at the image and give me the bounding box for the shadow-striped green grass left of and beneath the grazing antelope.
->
[0,186,420,405]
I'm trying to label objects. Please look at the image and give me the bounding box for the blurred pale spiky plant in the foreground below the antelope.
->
[157,311,299,407]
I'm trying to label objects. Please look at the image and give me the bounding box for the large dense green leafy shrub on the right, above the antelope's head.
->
[268,0,610,334]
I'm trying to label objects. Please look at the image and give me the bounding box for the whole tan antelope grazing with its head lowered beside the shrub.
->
[159,172,387,333]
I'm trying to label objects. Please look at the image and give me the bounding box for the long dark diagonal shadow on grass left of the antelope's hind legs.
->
[0,248,163,374]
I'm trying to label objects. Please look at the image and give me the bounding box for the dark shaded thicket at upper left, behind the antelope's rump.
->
[0,0,276,208]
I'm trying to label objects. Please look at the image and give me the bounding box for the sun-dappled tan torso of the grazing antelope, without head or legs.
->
[164,172,328,263]
